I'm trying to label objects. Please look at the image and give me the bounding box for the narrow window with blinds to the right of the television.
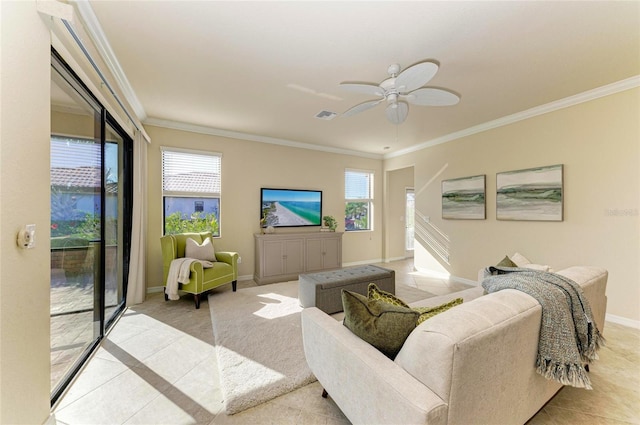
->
[344,170,373,231]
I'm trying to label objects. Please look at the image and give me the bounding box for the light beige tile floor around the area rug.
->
[53,260,640,425]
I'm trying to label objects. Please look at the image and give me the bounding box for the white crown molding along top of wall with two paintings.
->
[384,75,640,159]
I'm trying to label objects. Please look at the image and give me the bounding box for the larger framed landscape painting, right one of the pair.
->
[496,164,563,221]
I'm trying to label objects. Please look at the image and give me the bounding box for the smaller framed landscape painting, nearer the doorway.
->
[442,174,486,220]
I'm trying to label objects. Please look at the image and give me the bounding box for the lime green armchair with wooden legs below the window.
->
[160,232,238,309]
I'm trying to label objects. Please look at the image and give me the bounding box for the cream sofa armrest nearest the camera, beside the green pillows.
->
[302,307,447,424]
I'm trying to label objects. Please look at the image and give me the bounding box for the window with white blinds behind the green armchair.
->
[162,148,222,236]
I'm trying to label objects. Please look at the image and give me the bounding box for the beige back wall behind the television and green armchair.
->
[145,126,382,288]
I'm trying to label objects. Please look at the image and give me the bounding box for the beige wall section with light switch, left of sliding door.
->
[0,1,51,424]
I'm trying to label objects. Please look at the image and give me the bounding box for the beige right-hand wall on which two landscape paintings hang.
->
[385,89,640,321]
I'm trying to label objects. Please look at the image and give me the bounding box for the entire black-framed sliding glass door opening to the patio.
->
[50,48,132,403]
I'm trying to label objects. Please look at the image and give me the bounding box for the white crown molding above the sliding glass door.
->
[74,0,147,121]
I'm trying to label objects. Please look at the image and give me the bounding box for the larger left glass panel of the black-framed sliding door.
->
[50,64,102,392]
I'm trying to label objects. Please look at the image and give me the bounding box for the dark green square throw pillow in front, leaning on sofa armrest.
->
[342,289,419,360]
